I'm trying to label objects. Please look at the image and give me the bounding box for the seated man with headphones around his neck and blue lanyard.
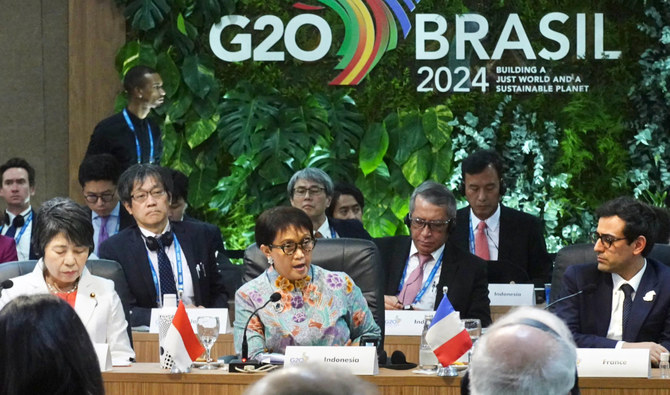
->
[100,164,227,326]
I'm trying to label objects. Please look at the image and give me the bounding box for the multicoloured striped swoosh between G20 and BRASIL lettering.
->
[293,0,421,85]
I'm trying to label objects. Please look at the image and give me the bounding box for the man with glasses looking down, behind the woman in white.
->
[79,154,135,255]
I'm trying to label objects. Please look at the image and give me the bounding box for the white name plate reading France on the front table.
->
[577,348,651,378]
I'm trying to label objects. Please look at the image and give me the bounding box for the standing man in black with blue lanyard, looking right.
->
[86,65,165,171]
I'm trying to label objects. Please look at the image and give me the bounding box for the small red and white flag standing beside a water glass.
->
[160,300,205,372]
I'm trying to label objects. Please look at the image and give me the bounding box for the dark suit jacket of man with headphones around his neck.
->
[99,221,228,326]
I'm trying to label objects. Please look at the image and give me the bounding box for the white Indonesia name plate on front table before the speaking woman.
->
[284,346,379,376]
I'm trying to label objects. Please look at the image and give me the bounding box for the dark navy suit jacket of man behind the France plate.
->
[556,258,670,348]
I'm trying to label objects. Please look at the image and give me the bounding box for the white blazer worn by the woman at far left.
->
[0,259,135,365]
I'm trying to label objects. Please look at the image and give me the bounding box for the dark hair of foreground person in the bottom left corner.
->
[0,294,105,395]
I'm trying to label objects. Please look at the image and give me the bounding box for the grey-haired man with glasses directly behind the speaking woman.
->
[286,167,372,240]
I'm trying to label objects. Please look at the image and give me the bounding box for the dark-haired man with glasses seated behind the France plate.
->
[556,197,670,365]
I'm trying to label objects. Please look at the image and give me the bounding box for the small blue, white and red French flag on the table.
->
[426,295,472,366]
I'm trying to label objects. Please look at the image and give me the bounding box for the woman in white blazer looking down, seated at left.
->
[0,198,135,365]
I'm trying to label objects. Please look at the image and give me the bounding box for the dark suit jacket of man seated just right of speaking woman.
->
[374,236,491,327]
